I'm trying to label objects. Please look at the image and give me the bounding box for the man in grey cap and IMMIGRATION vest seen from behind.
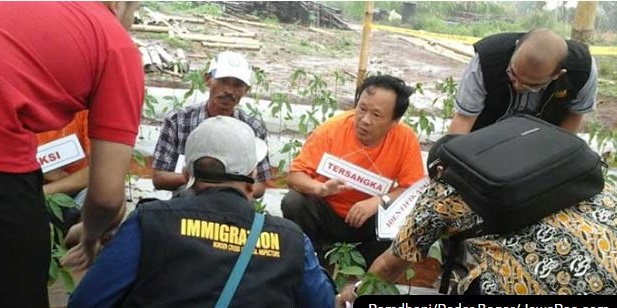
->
[68,116,334,307]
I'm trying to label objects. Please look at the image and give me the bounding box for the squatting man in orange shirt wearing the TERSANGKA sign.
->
[281,75,424,263]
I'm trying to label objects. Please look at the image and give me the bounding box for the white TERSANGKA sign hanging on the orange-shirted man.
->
[317,153,393,196]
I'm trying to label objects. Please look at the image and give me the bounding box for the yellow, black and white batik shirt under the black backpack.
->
[392,183,617,295]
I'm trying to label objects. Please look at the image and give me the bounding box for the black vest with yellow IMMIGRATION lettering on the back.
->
[123,188,304,308]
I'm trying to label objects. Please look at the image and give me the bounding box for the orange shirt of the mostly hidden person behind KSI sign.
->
[36,110,90,174]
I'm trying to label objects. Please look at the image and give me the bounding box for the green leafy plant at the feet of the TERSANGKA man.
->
[325,243,366,290]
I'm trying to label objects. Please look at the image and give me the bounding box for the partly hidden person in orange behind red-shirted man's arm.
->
[36,110,90,232]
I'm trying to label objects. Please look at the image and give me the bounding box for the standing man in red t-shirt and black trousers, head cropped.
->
[0,2,144,307]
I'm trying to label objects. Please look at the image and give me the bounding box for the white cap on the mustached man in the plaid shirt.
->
[208,51,253,86]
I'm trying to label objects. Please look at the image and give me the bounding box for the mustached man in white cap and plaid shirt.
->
[152,52,272,198]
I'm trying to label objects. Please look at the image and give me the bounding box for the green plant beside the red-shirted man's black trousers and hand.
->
[45,193,76,293]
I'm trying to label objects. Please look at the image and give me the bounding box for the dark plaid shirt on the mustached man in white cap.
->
[152,104,272,182]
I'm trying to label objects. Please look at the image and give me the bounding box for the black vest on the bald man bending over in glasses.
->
[472,33,591,131]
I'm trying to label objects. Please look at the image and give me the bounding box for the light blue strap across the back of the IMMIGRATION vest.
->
[214,213,265,308]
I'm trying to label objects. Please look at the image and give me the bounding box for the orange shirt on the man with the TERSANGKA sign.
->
[290,110,424,217]
